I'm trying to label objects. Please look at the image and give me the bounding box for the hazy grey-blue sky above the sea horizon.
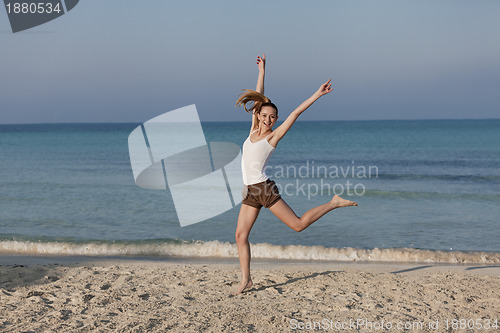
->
[0,0,500,124]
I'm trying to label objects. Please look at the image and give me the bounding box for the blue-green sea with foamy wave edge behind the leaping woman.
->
[0,119,500,262]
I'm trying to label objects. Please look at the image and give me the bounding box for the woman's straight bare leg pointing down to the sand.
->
[233,204,260,295]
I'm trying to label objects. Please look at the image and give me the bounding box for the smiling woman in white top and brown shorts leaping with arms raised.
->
[233,54,358,295]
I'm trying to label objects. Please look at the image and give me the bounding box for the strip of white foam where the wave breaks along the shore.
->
[0,240,500,264]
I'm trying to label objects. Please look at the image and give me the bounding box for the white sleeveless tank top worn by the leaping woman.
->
[241,131,275,185]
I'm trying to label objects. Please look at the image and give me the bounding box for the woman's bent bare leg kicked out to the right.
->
[269,195,358,232]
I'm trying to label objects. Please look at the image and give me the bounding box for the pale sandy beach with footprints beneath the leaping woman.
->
[0,256,500,332]
